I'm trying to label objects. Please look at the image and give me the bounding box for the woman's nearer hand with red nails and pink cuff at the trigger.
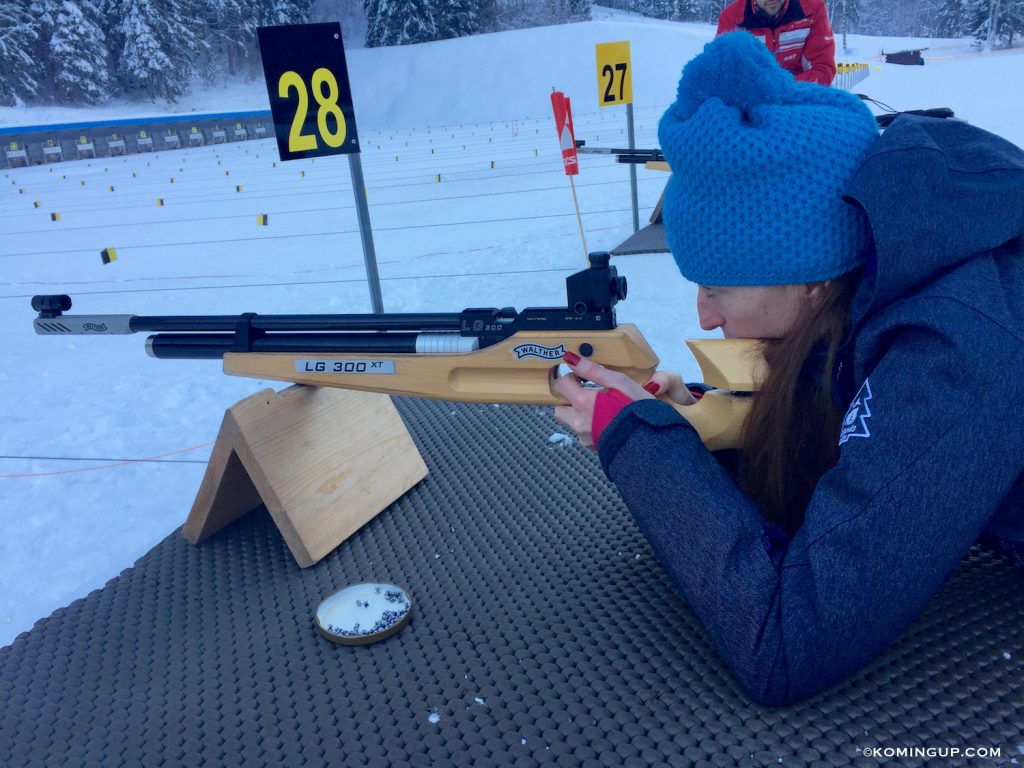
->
[553,352,659,451]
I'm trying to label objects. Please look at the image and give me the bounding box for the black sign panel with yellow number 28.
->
[256,22,359,160]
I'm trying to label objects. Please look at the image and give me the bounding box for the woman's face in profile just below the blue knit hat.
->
[697,283,824,339]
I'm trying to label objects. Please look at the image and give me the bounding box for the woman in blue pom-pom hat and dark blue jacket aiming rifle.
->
[555,33,1024,705]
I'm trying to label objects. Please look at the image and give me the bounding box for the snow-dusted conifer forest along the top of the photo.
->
[0,0,1024,106]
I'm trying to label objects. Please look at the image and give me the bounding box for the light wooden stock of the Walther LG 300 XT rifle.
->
[224,331,761,451]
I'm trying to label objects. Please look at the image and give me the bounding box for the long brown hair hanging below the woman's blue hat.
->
[737,269,860,536]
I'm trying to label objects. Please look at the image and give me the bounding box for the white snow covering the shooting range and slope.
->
[0,11,1024,651]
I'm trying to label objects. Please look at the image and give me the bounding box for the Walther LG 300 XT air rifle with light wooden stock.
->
[32,253,757,451]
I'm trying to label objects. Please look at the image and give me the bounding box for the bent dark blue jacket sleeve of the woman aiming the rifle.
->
[599,309,1024,706]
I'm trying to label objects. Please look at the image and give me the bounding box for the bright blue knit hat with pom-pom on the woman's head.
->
[658,32,879,286]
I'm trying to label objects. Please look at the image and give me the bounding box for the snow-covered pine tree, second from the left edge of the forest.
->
[49,0,113,104]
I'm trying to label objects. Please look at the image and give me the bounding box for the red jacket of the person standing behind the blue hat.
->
[718,0,836,85]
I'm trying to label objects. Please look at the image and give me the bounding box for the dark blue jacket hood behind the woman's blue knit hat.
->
[844,115,1024,316]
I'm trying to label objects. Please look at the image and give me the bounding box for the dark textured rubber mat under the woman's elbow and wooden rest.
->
[0,399,1024,768]
